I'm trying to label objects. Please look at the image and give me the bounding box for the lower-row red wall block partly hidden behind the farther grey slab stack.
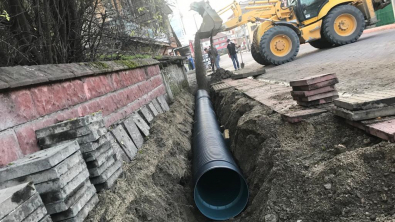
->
[15,115,58,155]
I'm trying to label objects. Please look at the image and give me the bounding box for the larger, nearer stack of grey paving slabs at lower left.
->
[0,141,99,222]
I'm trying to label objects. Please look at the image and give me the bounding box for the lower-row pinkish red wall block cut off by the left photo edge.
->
[0,130,23,167]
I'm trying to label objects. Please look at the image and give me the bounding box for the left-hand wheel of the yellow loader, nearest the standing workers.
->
[260,26,300,65]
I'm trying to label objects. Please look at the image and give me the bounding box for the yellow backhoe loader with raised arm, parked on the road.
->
[191,0,391,65]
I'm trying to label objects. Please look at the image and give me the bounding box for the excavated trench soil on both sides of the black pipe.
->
[88,89,395,222]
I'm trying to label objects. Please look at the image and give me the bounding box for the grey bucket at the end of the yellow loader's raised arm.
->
[191,1,223,39]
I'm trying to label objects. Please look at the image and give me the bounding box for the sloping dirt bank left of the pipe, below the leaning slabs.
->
[87,93,204,221]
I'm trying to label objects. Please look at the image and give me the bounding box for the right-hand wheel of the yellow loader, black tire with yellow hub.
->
[322,5,365,46]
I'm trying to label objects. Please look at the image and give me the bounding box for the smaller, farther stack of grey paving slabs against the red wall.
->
[36,112,122,191]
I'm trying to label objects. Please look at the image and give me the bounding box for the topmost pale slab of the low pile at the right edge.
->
[335,91,395,111]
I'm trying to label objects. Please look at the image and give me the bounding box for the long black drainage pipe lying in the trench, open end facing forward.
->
[193,90,249,220]
